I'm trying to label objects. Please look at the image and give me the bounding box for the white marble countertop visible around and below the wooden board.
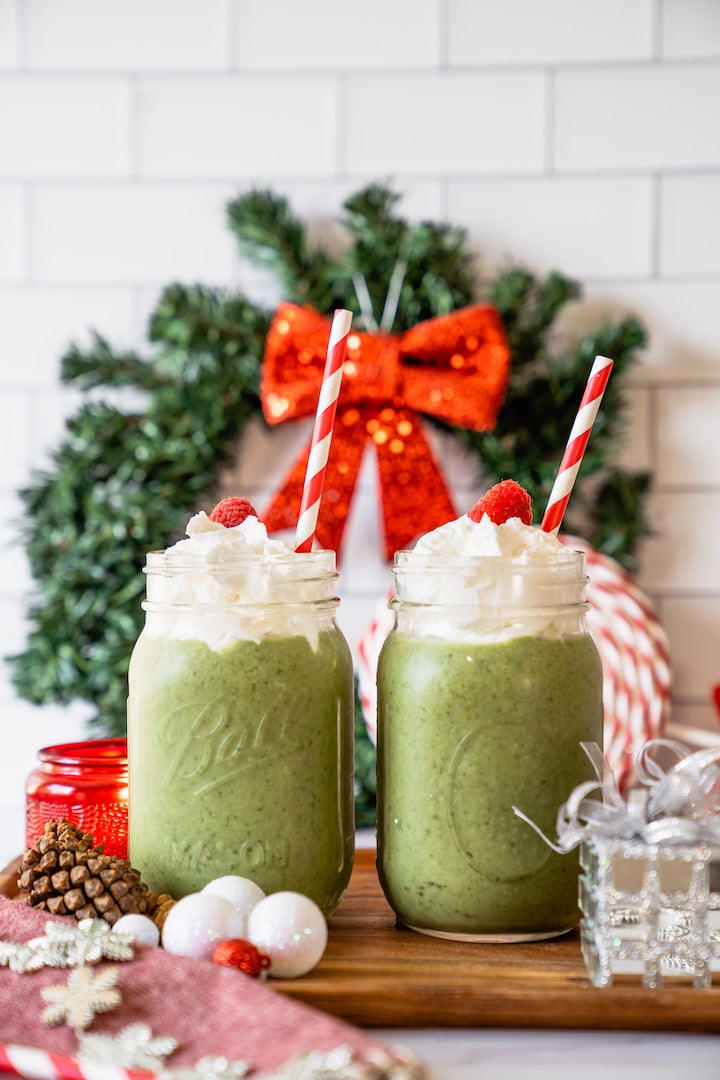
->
[0,800,720,1080]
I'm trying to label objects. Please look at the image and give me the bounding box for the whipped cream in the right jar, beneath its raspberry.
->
[393,514,586,642]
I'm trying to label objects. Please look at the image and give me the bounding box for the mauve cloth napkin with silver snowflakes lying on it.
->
[0,896,423,1077]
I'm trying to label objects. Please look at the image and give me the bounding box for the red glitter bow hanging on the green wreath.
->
[260,303,510,558]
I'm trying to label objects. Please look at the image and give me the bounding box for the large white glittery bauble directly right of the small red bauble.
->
[247,892,327,978]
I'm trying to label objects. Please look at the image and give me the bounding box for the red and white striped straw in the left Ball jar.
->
[295,308,353,552]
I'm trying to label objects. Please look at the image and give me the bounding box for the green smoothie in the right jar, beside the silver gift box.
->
[378,631,602,939]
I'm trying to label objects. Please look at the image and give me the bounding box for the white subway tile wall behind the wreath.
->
[0,0,720,859]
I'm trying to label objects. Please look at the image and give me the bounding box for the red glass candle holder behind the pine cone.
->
[25,739,127,859]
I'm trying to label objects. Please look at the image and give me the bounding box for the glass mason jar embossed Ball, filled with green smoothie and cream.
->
[127,551,354,914]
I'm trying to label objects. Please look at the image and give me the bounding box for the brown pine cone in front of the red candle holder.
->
[17,818,174,926]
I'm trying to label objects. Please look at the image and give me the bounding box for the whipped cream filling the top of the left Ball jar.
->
[145,511,337,650]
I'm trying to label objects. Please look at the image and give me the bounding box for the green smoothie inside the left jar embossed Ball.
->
[128,621,353,913]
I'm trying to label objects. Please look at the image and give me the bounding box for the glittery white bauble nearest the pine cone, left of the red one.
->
[163,892,246,957]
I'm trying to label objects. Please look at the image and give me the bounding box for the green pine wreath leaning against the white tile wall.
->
[9,184,650,823]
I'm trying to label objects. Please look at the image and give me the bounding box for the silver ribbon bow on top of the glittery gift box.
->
[513,739,720,854]
